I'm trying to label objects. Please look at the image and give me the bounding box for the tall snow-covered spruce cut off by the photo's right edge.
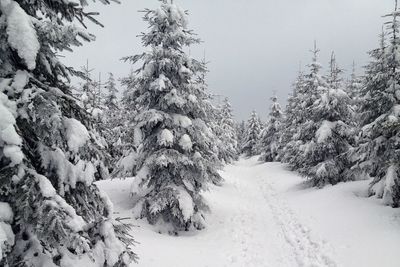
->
[358,7,400,207]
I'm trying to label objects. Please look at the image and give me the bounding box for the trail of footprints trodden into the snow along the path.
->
[260,180,339,267]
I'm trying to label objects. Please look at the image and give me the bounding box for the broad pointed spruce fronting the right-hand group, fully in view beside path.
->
[299,54,354,187]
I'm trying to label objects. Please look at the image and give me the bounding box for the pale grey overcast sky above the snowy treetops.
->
[64,0,394,119]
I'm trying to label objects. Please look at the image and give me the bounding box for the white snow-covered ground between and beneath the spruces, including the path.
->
[98,158,400,267]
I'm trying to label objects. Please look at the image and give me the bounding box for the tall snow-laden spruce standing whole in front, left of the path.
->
[122,0,221,234]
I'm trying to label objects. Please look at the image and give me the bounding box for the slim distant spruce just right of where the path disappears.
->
[259,96,283,162]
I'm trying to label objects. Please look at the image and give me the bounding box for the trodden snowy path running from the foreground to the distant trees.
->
[219,159,337,267]
